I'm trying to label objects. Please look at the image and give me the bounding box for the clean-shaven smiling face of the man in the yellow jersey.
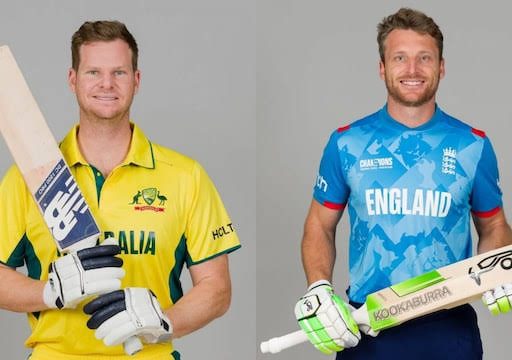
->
[68,39,140,119]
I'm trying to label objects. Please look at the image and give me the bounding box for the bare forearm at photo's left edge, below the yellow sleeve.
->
[0,265,48,312]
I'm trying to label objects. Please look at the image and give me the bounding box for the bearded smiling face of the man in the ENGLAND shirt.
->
[380,29,444,107]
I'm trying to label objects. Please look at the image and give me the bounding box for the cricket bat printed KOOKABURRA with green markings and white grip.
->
[260,245,512,354]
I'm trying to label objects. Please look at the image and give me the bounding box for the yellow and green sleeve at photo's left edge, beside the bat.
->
[0,166,30,268]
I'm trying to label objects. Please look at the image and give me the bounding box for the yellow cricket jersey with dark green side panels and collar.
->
[0,125,240,360]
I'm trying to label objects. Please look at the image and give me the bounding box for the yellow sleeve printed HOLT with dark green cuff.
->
[185,164,240,266]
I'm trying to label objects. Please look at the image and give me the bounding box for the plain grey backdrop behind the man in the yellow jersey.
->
[0,0,256,360]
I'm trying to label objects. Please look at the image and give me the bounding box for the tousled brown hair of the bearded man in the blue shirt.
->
[377,8,443,62]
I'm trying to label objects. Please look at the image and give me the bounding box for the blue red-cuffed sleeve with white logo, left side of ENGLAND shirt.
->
[313,131,350,210]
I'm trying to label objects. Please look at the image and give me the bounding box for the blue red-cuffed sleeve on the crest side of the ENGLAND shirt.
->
[470,137,502,217]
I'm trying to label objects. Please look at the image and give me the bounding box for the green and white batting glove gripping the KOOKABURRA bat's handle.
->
[295,280,361,355]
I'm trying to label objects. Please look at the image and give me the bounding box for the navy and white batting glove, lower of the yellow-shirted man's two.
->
[84,288,172,346]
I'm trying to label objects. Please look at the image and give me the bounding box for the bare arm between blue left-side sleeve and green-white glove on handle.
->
[302,199,343,284]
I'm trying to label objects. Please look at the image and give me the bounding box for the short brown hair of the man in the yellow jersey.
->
[71,20,139,71]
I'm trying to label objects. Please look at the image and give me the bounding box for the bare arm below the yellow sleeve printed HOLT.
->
[165,255,231,338]
